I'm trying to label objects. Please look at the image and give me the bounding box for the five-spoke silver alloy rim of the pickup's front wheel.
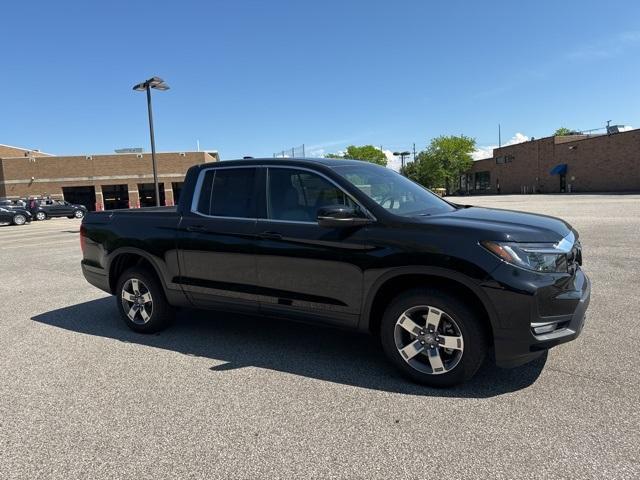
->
[394,305,464,375]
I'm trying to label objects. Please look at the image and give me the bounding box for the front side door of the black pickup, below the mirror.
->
[256,166,365,326]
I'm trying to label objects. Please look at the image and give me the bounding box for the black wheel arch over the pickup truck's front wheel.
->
[359,267,497,341]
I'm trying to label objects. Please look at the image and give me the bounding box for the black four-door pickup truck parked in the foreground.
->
[81,159,590,386]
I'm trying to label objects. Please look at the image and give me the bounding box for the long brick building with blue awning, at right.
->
[460,129,640,194]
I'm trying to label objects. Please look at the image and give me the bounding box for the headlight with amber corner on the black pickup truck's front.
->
[480,233,575,273]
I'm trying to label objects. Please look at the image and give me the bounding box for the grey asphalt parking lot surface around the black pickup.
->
[0,195,640,479]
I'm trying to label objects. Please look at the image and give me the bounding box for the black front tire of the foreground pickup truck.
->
[380,288,489,387]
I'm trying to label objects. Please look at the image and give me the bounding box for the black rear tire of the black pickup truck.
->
[115,267,174,333]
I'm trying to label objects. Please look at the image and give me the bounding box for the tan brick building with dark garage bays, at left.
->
[0,145,219,210]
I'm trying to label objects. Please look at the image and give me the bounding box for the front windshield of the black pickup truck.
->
[333,162,455,216]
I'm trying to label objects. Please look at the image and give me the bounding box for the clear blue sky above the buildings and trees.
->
[0,0,640,167]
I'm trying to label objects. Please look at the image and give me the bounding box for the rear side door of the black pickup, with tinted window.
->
[178,167,258,311]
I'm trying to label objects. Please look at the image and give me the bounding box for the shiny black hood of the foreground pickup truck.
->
[418,207,577,243]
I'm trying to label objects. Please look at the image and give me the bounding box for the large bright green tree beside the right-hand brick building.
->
[407,135,476,193]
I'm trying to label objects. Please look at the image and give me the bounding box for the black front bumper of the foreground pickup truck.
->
[485,264,591,367]
